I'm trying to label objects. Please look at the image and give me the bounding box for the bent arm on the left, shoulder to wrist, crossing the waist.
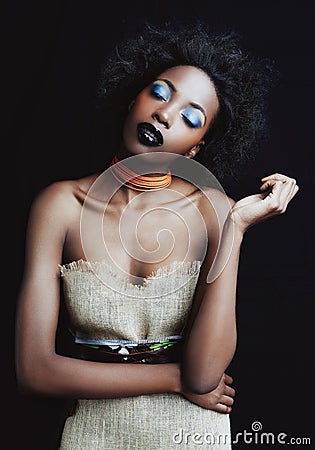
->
[16,183,180,398]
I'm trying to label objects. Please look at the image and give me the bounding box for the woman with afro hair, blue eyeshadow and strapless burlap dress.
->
[16,25,298,450]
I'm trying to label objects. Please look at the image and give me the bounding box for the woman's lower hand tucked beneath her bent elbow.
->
[182,373,235,414]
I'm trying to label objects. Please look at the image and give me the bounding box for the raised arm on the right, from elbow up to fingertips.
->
[182,174,298,394]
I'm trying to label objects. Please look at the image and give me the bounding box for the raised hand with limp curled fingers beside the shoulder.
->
[230,173,299,232]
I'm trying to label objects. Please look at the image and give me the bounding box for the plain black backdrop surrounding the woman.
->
[1,0,315,450]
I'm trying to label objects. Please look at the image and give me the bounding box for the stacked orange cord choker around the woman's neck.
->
[110,156,172,191]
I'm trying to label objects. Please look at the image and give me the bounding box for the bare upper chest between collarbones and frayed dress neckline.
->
[67,192,208,277]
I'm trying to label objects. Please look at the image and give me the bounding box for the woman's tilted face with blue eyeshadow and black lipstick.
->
[122,66,219,157]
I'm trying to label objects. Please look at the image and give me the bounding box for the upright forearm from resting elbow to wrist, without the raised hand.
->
[182,220,243,394]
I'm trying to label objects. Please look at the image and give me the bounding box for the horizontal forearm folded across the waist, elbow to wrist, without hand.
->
[19,355,180,399]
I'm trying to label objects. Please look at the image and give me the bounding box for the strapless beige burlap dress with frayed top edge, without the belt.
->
[60,260,231,450]
